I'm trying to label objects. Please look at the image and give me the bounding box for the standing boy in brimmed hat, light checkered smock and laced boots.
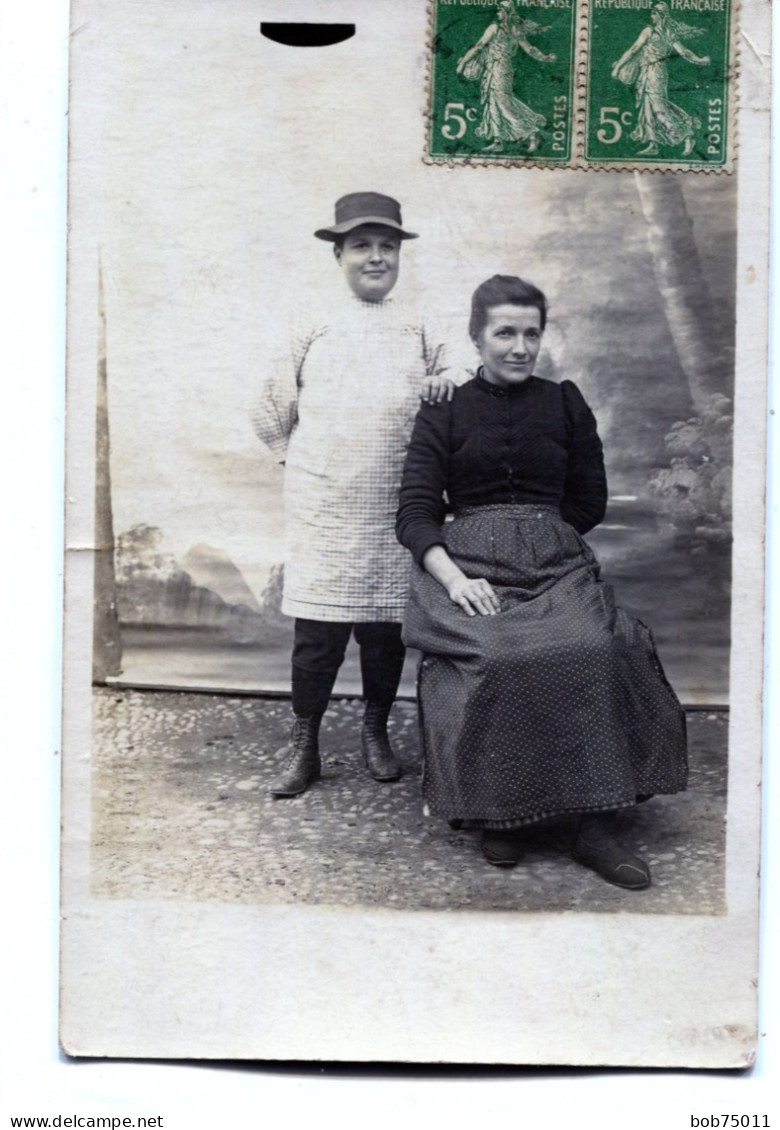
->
[253,192,453,797]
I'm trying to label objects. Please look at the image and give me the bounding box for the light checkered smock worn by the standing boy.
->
[253,295,442,623]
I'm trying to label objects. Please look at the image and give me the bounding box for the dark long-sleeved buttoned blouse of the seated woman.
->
[396,376,607,564]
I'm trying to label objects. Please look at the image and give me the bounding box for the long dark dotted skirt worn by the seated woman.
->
[404,505,687,828]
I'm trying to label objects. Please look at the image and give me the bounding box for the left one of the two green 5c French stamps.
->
[426,0,577,165]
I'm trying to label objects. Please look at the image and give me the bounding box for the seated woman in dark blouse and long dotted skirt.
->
[397,275,687,890]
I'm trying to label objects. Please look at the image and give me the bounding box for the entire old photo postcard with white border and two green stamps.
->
[61,0,770,1068]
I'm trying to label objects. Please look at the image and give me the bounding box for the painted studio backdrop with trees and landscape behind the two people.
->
[88,0,736,704]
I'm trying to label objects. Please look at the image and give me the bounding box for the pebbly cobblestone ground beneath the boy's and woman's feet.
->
[92,689,728,914]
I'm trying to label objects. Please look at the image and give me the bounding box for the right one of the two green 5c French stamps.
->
[584,0,734,170]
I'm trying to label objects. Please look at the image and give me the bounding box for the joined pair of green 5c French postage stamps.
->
[426,0,735,172]
